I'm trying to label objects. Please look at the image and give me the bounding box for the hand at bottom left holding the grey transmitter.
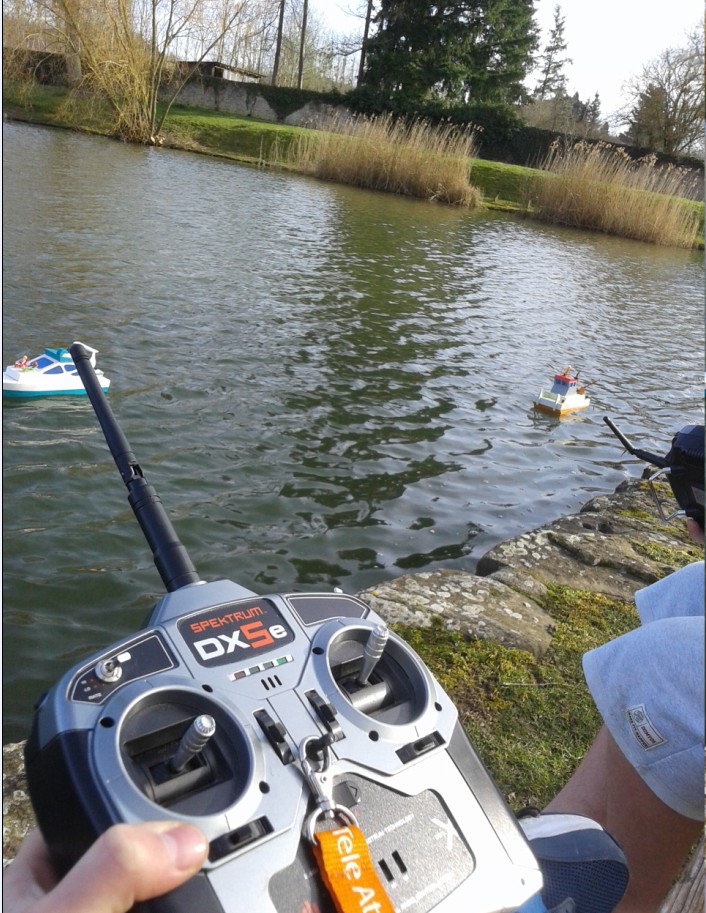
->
[3,821,208,913]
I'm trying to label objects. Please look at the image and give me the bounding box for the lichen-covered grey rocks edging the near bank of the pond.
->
[3,481,703,867]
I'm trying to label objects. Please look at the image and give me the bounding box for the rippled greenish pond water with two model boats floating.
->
[3,123,704,741]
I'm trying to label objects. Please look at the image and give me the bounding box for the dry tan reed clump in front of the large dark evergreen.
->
[289,115,480,207]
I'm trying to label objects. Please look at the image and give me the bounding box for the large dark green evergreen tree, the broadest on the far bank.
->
[363,0,536,104]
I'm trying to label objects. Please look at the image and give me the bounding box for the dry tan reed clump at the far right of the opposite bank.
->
[527,142,701,247]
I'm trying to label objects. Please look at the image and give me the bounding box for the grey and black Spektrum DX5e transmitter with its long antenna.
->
[26,344,542,913]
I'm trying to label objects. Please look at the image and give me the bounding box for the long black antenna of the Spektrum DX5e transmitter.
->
[69,342,200,592]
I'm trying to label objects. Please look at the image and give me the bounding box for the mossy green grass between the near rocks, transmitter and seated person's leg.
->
[395,586,638,809]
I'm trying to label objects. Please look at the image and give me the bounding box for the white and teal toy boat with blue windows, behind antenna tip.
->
[2,343,110,396]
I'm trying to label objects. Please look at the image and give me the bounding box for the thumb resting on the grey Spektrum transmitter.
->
[32,821,208,913]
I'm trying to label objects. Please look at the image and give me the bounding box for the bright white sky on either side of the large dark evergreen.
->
[310,0,704,127]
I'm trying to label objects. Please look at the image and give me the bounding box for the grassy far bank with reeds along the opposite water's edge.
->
[4,84,704,248]
